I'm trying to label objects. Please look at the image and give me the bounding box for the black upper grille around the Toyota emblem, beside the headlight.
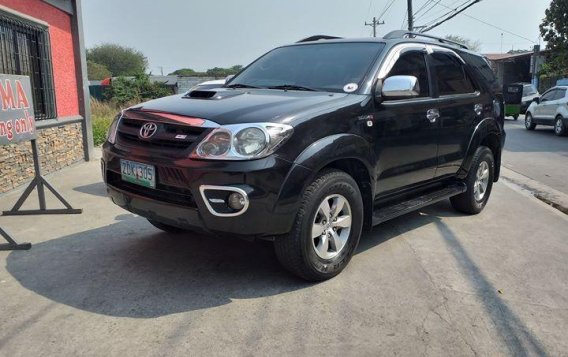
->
[118,115,207,150]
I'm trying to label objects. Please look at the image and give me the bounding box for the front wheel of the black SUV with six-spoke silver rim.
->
[274,170,363,281]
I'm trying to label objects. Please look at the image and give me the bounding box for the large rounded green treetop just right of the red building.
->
[87,43,148,77]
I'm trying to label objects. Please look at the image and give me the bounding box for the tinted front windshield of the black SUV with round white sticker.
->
[228,42,385,93]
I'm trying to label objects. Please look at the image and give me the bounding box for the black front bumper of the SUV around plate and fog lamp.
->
[101,143,295,237]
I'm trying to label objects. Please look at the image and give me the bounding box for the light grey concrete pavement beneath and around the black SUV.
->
[0,151,568,356]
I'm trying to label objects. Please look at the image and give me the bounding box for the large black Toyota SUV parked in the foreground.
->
[102,31,505,281]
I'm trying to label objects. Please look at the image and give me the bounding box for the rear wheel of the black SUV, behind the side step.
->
[450,146,495,214]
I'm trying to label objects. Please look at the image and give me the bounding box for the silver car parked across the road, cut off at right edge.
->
[525,86,568,136]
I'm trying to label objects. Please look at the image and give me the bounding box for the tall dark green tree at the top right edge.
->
[540,0,568,74]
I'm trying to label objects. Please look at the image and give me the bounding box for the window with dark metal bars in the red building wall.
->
[0,11,57,120]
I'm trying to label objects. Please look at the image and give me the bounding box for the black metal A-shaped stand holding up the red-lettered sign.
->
[2,140,83,217]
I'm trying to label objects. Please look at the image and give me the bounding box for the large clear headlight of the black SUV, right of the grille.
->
[191,123,294,160]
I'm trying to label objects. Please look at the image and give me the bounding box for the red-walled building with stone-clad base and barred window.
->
[0,0,93,193]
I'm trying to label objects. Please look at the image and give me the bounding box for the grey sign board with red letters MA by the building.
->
[0,73,36,146]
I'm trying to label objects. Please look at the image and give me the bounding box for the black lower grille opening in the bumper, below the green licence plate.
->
[106,168,197,208]
